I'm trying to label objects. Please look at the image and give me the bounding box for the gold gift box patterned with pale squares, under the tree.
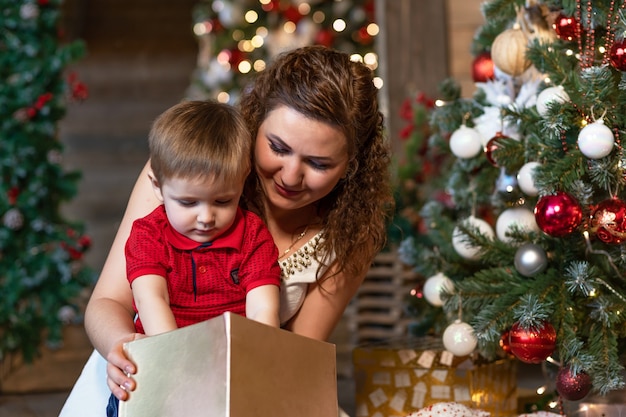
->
[352,337,517,417]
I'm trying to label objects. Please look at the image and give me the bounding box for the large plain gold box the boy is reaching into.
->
[119,313,338,417]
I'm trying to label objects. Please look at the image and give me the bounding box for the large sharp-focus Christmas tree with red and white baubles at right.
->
[399,0,626,401]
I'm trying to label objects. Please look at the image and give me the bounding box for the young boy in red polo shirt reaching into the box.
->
[107,101,280,417]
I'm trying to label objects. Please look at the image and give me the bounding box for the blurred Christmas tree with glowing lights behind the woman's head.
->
[187,0,379,103]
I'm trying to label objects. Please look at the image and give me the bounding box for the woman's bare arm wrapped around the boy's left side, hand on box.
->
[85,159,159,399]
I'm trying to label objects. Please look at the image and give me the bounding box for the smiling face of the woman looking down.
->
[254,106,348,210]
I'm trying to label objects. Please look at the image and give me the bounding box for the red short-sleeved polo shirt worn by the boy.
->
[126,205,280,333]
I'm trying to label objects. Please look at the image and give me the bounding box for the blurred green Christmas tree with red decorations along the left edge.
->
[0,0,93,360]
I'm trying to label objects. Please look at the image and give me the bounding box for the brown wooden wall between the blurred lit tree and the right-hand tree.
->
[376,0,484,152]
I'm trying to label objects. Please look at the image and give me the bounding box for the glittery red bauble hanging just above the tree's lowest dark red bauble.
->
[509,321,556,363]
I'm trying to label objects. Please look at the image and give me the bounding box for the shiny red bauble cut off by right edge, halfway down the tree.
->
[591,198,626,245]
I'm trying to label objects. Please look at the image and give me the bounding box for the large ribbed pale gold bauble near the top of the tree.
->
[491,28,530,77]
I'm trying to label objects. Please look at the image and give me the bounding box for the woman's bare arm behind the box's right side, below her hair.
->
[285,271,365,341]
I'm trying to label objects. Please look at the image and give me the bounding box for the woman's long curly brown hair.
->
[240,46,394,276]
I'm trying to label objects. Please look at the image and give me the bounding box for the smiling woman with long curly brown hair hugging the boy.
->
[62,46,393,415]
